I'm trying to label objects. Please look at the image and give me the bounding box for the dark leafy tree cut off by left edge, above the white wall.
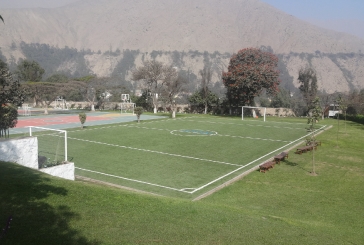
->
[0,61,25,137]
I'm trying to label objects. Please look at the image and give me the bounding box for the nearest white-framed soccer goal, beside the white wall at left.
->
[29,126,68,168]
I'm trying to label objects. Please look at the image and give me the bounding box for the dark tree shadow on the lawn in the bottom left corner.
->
[0,162,100,245]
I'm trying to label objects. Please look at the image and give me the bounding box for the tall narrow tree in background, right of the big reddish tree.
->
[298,67,318,113]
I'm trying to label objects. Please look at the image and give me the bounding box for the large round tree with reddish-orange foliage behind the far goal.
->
[222,48,280,110]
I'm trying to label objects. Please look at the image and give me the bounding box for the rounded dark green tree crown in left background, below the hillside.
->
[16,60,44,82]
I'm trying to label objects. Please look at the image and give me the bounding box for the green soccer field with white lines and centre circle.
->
[37,116,324,199]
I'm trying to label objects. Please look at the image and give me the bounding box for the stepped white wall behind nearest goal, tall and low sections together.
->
[0,137,75,180]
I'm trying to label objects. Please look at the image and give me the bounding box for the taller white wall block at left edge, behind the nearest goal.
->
[0,137,38,169]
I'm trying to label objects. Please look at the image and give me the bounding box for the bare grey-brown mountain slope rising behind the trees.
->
[0,0,364,92]
